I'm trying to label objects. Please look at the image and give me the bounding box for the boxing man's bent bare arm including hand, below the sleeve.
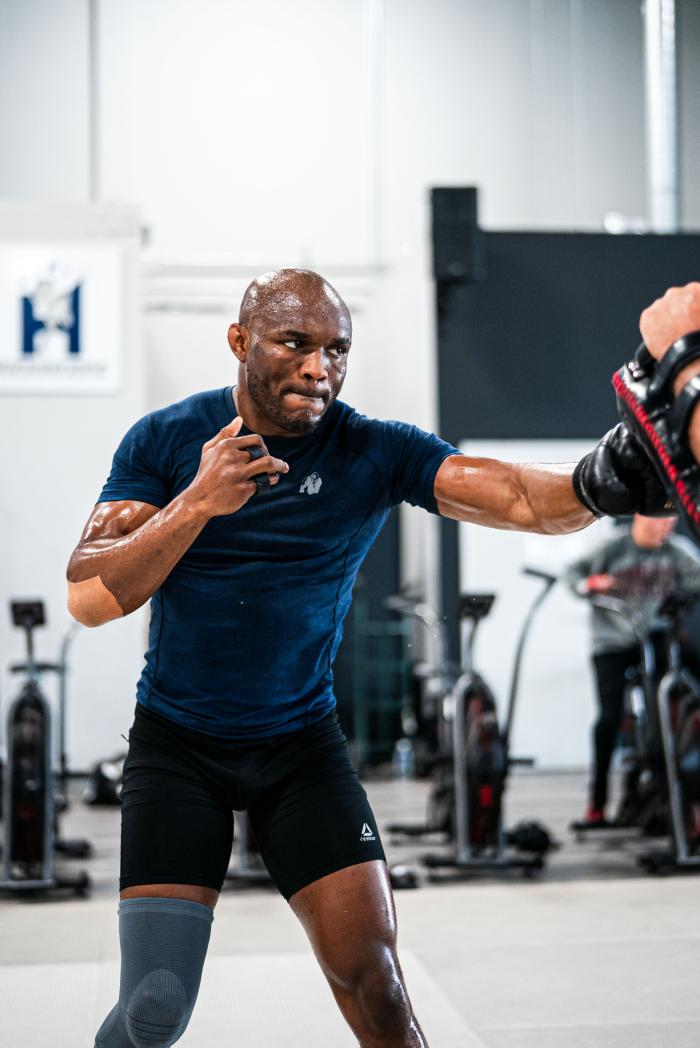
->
[67,417,289,626]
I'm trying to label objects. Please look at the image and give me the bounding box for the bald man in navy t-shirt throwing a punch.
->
[68,269,665,1048]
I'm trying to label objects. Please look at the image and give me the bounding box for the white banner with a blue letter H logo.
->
[0,243,124,395]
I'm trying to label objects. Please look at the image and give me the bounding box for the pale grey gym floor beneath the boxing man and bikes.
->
[0,771,700,1048]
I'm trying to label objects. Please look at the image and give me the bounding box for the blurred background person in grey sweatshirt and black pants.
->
[566,514,700,825]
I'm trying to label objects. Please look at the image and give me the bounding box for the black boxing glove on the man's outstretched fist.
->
[571,422,674,517]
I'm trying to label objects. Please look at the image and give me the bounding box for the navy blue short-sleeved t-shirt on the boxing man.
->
[99,387,459,739]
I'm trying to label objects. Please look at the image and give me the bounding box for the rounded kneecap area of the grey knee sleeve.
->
[125,968,195,1048]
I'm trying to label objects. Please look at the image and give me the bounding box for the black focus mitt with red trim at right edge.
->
[613,331,700,542]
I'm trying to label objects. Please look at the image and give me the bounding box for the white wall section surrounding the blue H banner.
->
[0,201,145,767]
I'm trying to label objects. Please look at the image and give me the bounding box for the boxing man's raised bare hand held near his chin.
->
[188,415,289,518]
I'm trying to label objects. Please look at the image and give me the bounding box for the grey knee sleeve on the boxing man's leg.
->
[95,898,214,1048]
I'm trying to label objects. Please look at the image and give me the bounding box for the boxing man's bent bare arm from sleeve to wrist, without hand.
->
[67,492,209,626]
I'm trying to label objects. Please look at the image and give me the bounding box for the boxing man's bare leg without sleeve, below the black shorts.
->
[289,860,428,1048]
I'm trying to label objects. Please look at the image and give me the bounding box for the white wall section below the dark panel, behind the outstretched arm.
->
[460,440,613,767]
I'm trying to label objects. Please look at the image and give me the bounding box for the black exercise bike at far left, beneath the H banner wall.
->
[0,601,90,896]
